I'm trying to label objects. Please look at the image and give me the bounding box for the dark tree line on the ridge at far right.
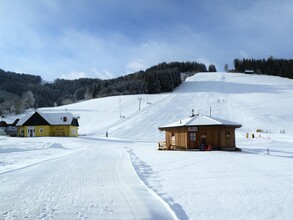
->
[234,57,293,79]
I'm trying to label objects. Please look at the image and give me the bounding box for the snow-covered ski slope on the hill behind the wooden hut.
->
[54,73,293,138]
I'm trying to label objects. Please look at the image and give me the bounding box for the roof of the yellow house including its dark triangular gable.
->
[16,111,78,126]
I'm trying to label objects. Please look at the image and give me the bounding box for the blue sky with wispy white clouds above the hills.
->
[0,0,293,80]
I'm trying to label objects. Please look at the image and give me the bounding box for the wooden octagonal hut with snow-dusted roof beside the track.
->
[159,114,242,150]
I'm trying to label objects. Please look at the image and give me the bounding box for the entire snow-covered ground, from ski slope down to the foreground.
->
[0,73,293,219]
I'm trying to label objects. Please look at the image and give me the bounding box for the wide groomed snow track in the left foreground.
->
[0,139,174,219]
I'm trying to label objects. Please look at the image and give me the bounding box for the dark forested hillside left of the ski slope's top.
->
[0,62,207,114]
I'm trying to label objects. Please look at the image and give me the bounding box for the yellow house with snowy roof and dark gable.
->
[16,111,79,137]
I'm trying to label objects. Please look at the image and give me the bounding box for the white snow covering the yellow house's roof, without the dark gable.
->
[16,111,77,126]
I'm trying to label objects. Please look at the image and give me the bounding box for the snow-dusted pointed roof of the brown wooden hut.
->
[159,114,242,130]
